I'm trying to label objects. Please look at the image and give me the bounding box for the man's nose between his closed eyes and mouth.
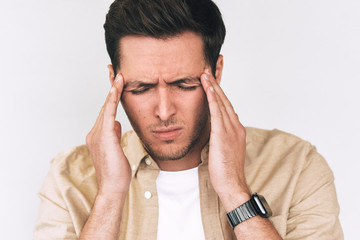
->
[155,87,176,121]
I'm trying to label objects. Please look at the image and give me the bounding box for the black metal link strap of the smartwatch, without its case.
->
[226,201,257,228]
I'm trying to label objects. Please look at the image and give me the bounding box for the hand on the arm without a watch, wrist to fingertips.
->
[86,74,131,197]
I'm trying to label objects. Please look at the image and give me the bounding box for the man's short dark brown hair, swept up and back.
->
[104,0,225,74]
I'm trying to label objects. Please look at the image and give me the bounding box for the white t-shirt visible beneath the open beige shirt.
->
[156,167,205,240]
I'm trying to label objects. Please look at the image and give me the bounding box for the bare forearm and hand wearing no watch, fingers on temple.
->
[79,75,131,239]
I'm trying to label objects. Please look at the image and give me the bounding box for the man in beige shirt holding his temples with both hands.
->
[35,0,343,239]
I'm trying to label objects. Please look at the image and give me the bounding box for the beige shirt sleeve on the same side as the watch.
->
[285,147,344,240]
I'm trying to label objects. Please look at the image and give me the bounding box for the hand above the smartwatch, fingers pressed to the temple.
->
[201,69,250,211]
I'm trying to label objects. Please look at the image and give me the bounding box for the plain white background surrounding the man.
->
[0,0,360,239]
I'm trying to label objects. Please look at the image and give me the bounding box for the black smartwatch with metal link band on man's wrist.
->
[226,193,272,228]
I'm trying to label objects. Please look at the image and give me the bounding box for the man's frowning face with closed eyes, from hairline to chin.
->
[120,32,209,160]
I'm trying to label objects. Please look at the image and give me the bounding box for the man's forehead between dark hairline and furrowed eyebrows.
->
[120,32,205,81]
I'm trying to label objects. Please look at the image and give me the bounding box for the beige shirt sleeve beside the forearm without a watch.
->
[34,167,77,240]
